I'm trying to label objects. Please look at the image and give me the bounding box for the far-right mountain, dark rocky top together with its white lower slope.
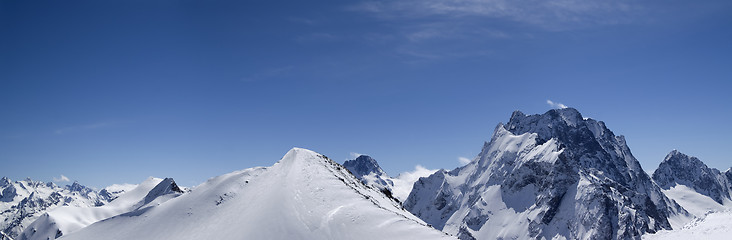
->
[653,150,732,217]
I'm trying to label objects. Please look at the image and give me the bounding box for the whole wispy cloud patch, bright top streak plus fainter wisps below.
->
[346,0,648,60]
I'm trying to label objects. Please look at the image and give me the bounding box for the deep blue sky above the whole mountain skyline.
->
[0,0,732,187]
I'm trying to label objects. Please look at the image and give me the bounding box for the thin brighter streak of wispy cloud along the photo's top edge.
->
[349,0,643,31]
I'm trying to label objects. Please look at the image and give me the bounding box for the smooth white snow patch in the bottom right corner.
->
[643,209,732,240]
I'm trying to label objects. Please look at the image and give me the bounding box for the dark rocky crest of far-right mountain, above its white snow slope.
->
[653,150,730,204]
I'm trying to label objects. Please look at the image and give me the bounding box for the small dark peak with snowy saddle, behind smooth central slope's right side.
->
[343,155,435,202]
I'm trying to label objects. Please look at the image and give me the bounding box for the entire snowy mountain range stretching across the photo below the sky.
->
[0,108,732,240]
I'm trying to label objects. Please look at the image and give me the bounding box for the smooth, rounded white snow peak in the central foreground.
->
[62,148,453,240]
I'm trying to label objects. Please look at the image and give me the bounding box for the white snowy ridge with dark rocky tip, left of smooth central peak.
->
[16,177,184,240]
